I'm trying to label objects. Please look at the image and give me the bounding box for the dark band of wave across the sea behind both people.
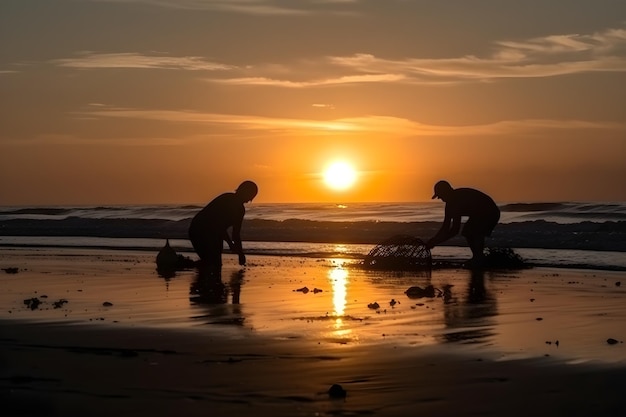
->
[0,217,626,252]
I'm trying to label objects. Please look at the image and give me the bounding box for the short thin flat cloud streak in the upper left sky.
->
[50,51,234,71]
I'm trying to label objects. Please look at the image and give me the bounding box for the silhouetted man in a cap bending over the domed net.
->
[426,181,500,266]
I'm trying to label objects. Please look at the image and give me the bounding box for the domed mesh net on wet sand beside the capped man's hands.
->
[363,235,432,271]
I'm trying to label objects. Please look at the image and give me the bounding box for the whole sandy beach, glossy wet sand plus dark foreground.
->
[0,248,626,416]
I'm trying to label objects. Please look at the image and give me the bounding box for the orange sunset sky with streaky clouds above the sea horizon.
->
[0,0,626,205]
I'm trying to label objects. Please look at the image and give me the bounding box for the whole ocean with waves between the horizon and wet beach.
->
[0,201,626,270]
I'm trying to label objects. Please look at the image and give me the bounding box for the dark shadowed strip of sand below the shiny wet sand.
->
[0,323,626,417]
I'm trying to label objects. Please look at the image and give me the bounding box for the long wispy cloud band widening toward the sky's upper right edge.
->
[213,28,626,88]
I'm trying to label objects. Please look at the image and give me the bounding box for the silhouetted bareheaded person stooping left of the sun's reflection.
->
[189,181,259,269]
